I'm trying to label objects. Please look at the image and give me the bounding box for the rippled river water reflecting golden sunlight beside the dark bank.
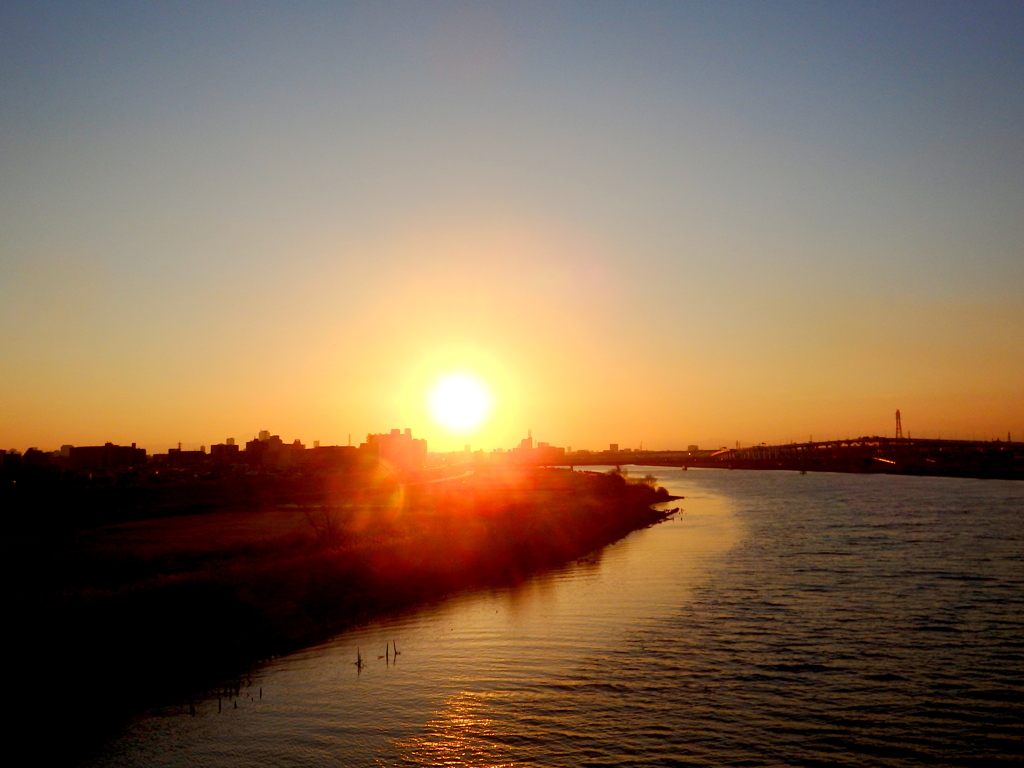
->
[92,467,1024,766]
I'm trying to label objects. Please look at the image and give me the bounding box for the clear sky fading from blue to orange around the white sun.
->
[0,0,1024,452]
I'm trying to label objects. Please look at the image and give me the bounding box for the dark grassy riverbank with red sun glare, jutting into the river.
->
[14,470,671,765]
